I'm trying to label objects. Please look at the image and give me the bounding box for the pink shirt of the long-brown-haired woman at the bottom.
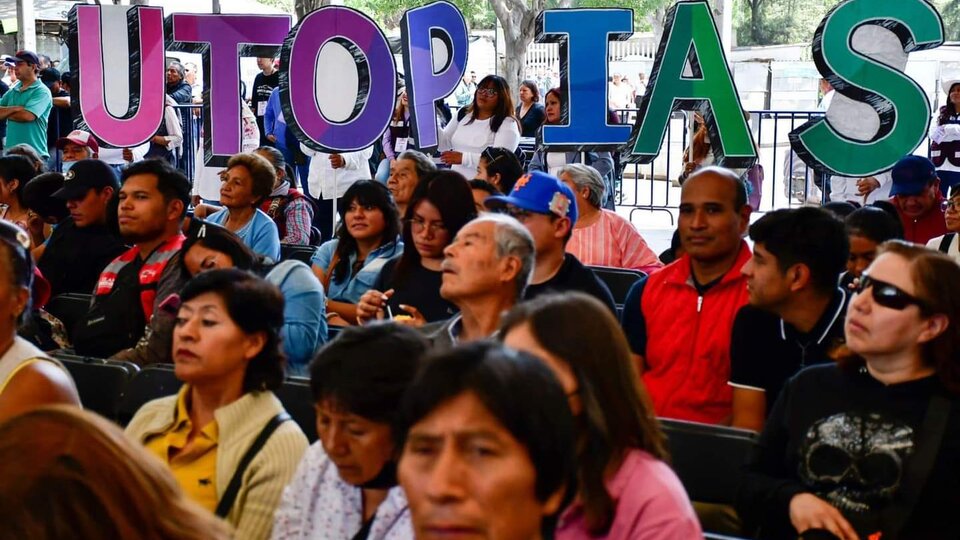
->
[556,449,703,540]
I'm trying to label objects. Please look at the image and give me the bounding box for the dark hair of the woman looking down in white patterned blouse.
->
[310,322,428,440]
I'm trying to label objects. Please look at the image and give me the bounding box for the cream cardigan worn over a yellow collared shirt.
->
[126,385,308,540]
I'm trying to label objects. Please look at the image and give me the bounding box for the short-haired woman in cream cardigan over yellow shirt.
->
[126,269,307,539]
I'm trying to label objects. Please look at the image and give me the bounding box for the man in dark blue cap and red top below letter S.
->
[890,155,947,244]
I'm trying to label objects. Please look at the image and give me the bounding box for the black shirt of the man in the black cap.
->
[37,218,127,296]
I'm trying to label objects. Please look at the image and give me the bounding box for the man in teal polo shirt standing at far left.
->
[0,51,53,158]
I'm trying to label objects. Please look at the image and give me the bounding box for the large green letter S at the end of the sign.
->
[790,0,943,176]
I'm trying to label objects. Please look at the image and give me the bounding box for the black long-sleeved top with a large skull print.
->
[737,365,960,540]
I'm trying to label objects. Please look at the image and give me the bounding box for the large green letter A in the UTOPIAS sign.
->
[622,0,757,168]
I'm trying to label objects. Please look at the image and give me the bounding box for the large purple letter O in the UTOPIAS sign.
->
[280,6,397,152]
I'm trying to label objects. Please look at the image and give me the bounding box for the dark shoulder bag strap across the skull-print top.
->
[881,393,950,540]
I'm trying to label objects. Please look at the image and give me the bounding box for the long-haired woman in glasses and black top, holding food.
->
[357,171,477,326]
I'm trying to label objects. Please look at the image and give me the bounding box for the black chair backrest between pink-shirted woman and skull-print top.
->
[659,418,757,504]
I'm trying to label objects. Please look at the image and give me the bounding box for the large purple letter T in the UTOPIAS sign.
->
[167,13,290,166]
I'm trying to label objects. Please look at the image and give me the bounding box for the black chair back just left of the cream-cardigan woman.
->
[55,354,140,421]
